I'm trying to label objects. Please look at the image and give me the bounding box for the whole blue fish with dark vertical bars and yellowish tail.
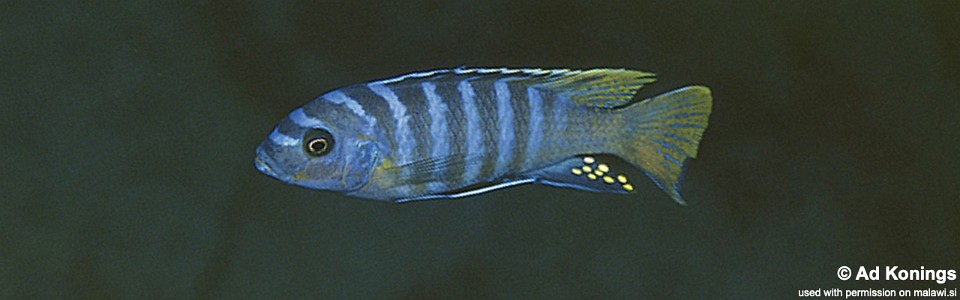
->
[254,67,712,205]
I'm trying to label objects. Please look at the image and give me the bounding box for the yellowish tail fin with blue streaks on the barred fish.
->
[619,86,713,204]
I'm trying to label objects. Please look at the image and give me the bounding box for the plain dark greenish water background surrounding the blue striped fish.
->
[0,1,960,299]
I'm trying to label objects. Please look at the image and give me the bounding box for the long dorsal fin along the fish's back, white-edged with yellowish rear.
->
[378,67,656,108]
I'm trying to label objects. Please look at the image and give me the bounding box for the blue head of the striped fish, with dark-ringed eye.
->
[254,99,382,192]
